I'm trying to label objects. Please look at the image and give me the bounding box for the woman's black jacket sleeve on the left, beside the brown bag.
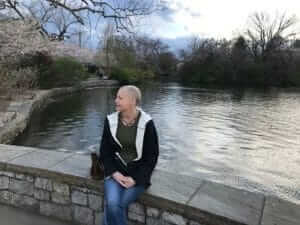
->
[100,118,117,177]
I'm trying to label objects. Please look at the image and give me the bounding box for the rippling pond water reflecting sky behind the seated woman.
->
[16,83,300,203]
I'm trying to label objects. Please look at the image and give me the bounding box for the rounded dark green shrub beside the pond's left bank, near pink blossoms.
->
[38,57,88,88]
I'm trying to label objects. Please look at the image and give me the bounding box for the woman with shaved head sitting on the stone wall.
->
[100,85,159,225]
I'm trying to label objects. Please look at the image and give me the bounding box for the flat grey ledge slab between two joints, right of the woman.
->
[188,181,264,225]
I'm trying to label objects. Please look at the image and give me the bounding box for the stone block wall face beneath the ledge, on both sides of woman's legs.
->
[0,171,204,225]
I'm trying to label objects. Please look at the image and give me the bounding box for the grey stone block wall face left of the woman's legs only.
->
[0,171,103,225]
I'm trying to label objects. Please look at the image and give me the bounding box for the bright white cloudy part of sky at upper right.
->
[144,0,300,39]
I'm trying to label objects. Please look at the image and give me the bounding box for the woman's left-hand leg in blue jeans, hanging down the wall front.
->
[103,178,126,225]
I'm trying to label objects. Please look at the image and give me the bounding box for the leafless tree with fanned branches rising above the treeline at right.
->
[245,12,297,59]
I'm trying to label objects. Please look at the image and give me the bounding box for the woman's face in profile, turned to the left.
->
[115,88,135,112]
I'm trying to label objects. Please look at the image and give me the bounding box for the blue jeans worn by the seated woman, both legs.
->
[102,178,145,225]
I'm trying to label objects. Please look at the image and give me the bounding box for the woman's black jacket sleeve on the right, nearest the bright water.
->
[133,120,159,185]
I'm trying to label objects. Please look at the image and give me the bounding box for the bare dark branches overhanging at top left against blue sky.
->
[0,0,158,34]
